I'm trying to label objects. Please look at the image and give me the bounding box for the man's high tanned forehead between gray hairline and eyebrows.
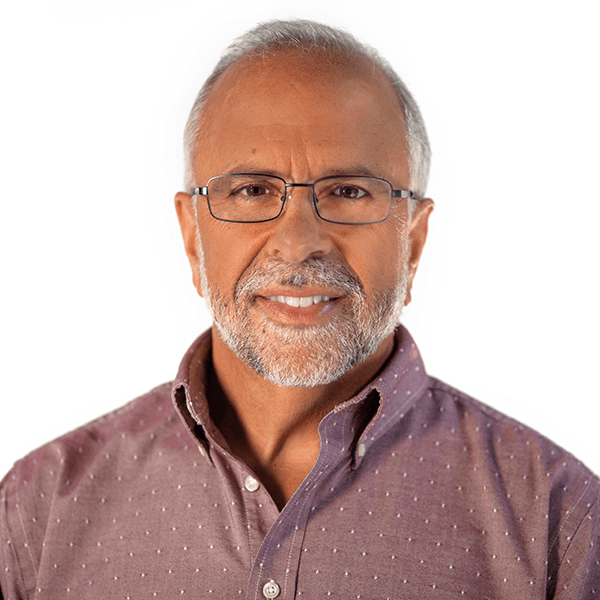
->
[196,50,407,176]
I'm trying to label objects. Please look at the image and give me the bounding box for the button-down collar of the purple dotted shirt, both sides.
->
[172,325,428,466]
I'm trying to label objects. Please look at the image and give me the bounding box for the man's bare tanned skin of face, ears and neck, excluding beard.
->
[175,51,433,509]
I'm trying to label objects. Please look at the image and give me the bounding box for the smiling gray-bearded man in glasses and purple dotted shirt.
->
[0,21,600,600]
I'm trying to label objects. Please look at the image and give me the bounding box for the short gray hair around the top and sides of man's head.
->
[184,19,431,199]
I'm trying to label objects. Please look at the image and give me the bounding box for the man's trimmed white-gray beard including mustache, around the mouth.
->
[199,246,408,387]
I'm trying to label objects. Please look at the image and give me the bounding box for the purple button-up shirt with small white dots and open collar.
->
[0,327,600,600]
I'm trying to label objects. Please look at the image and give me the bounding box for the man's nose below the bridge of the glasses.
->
[266,187,333,263]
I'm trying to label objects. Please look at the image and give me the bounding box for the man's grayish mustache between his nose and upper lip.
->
[235,257,364,300]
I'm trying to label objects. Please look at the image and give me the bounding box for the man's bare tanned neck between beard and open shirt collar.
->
[209,327,394,509]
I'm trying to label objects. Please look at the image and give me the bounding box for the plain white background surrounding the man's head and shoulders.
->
[0,0,600,472]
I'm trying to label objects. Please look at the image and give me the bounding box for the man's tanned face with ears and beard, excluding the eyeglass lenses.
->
[177,52,431,386]
